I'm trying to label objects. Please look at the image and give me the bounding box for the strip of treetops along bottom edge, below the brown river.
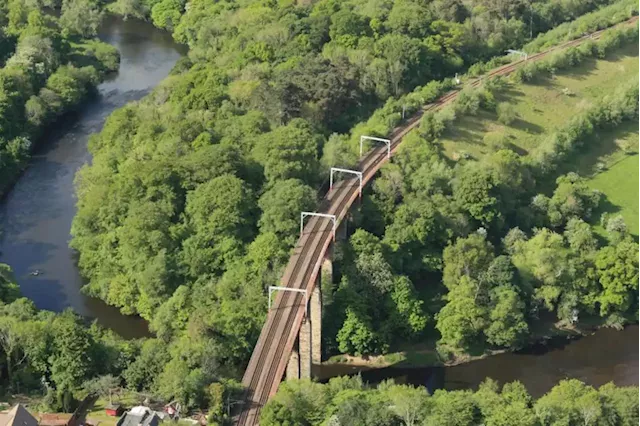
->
[260,376,640,426]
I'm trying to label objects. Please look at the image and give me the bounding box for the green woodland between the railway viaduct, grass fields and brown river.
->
[326,26,640,360]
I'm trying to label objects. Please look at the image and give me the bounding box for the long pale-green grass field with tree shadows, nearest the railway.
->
[440,45,640,158]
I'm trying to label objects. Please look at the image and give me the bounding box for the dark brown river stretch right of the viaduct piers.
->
[321,326,640,397]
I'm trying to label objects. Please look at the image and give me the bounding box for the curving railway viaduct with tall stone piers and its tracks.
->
[236,17,639,426]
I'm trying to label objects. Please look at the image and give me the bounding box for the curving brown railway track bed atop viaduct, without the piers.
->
[236,17,640,426]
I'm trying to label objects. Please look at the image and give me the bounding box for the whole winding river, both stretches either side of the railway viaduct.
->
[0,10,640,396]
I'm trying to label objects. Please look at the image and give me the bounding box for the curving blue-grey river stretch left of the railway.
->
[0,17,186,338]
